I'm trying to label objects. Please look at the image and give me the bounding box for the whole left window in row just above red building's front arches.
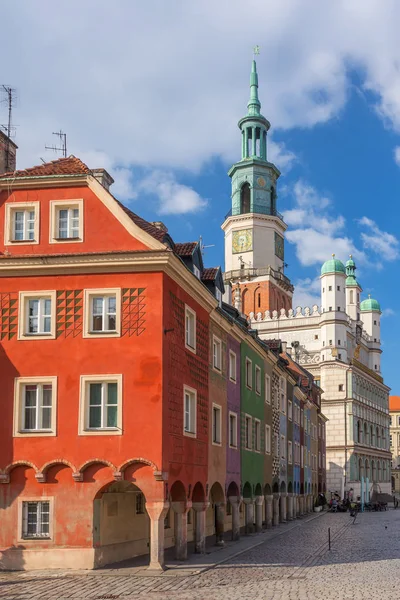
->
[14,377,57,437]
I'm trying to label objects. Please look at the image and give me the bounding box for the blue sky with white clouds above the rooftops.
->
[0,0,400,393]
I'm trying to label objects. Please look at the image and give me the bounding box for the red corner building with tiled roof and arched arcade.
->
[0,157,218,569]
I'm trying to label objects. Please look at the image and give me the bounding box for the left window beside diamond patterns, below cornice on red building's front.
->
[18,290,56,340]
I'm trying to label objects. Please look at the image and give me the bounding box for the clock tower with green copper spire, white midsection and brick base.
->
[222,60,293,315]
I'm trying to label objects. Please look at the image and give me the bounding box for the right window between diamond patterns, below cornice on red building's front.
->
[83,289,121,337]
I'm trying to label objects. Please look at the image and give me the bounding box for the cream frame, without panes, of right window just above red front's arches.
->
[78,373,123,435]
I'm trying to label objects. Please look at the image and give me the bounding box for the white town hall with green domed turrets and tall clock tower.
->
[222,61,391,500]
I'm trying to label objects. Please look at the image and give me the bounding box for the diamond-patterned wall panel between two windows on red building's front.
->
[56,290,83,337]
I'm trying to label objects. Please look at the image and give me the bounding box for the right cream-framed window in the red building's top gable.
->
[50,200,83,244]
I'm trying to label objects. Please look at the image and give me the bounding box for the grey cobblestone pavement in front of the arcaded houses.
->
[0,510,400,600]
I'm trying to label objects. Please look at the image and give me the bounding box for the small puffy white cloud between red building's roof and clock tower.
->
[138,170,207,215]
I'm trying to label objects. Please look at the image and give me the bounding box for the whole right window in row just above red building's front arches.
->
[79,375,122,435]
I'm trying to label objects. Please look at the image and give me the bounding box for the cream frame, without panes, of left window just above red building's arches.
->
[13,376,57,437]
